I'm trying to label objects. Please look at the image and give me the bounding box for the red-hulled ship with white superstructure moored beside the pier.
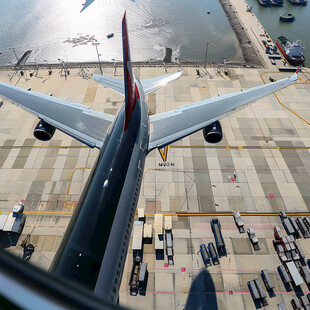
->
[276,36,305,66]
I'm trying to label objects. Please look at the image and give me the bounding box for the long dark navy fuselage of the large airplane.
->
[50,80,149,302]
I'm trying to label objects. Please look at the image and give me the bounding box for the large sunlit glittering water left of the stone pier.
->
[0,0,242,65]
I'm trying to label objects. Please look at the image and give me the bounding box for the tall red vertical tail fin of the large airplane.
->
[122,12,136,132]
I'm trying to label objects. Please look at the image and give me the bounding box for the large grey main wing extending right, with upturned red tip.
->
[149,72,297,151]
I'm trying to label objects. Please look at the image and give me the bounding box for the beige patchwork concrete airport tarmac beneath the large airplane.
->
[0,63,310,310]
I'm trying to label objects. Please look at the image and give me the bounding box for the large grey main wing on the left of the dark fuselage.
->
[0,82,114,148]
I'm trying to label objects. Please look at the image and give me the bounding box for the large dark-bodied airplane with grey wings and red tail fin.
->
[0,12,298,303]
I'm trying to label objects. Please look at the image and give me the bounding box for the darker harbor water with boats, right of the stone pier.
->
[247,0,310,66]
